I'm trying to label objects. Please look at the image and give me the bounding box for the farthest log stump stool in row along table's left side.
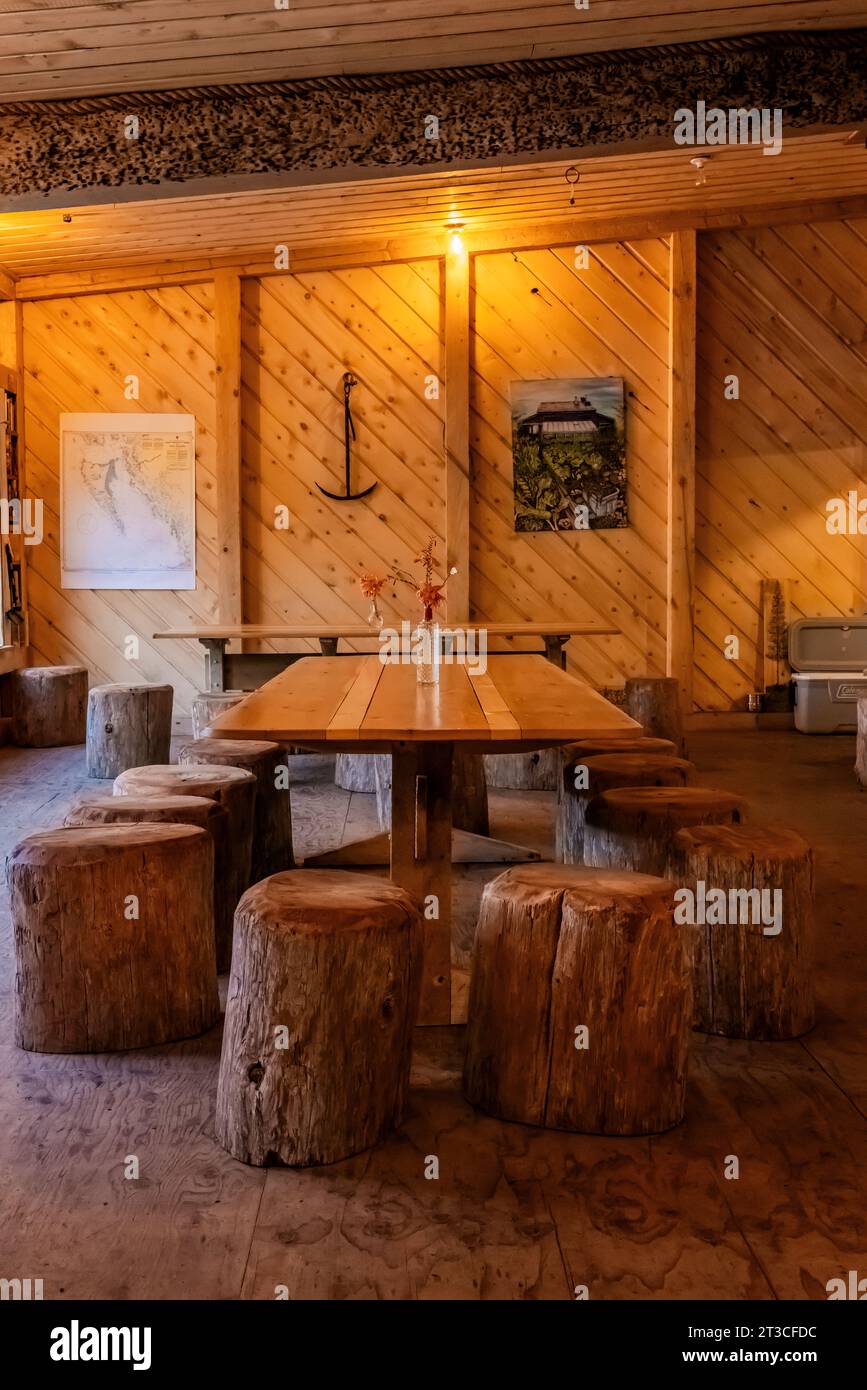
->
[178,738,295,883]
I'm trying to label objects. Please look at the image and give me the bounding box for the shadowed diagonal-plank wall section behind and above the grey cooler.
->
[695,221,867,710]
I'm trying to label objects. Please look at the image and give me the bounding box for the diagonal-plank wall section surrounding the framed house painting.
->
[471,239,668,685]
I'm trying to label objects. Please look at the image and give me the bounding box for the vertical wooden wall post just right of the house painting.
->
[666,231,696,714]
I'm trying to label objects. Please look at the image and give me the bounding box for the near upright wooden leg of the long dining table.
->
[390,744,453,1024]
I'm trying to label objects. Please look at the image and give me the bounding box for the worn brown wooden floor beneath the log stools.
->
[0,733,867,1300]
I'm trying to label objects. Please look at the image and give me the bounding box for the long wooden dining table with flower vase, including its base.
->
[213,655,639,1024]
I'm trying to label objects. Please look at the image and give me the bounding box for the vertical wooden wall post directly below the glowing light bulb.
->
[445,247,470,623]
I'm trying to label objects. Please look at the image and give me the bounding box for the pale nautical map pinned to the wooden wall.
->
[60,414,196,589]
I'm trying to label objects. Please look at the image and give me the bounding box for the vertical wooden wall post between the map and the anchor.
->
[214,271,243,623]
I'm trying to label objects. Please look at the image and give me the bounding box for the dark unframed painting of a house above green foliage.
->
[511,377,629,531]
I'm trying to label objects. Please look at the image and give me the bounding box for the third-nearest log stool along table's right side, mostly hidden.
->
[554,753,695,865]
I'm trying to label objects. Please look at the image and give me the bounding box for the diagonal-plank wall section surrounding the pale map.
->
[24,286,217,720]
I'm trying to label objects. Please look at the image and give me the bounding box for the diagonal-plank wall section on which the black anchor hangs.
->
[234,261,445,649]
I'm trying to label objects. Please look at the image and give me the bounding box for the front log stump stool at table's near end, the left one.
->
[217,869,422,1168]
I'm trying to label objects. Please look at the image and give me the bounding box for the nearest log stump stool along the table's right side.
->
[672,826,816,1040]
